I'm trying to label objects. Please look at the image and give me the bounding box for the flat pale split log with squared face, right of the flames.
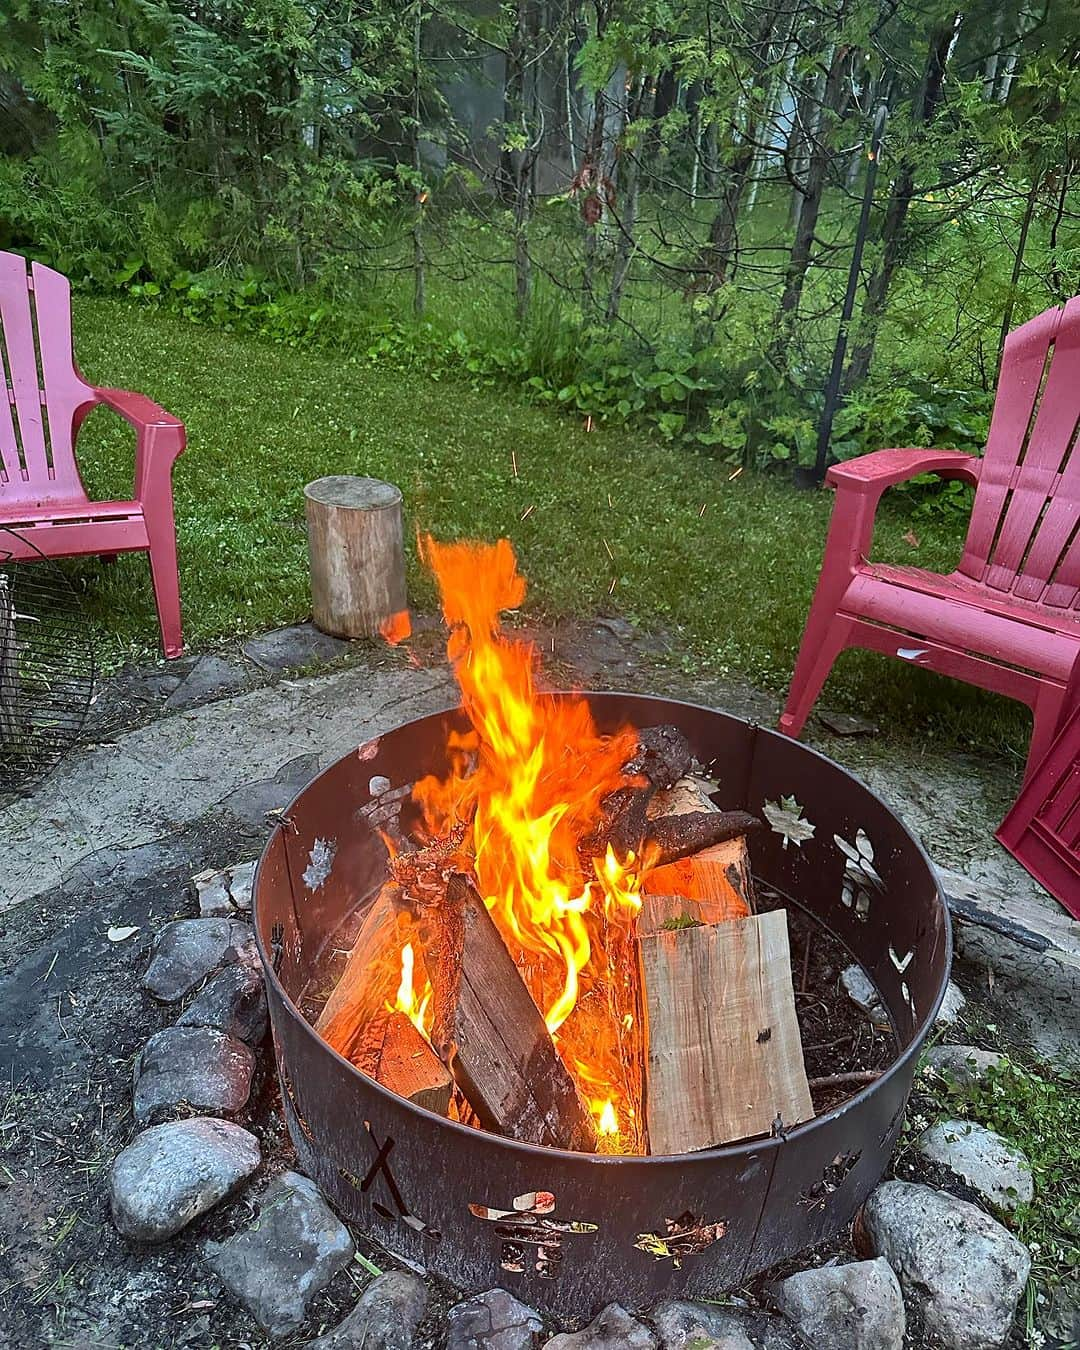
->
[639,910,814,1154]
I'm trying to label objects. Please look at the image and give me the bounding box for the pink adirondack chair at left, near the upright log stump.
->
[0,252,185,656]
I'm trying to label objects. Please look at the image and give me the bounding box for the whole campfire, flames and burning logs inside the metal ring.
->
[316,539,814,1154]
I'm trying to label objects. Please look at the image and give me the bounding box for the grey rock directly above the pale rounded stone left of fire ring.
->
[134,1026,255,1125]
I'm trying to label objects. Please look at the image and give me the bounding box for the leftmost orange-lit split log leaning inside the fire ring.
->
[315,883,408,1056]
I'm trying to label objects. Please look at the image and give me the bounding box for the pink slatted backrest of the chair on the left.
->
[0,252,95,504]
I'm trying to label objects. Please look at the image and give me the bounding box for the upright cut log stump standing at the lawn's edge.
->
[304,474,406,637]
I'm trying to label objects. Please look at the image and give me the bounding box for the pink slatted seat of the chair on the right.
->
[840,563,1080,684]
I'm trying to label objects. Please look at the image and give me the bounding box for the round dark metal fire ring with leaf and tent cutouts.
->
[254,694,952,1316]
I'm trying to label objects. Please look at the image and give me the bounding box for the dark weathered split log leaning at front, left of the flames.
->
[421,872,597,1153]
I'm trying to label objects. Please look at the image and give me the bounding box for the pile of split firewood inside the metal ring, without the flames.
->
[317,728,813,1154]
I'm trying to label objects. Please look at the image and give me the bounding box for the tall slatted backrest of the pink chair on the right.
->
[960,298,1080,606]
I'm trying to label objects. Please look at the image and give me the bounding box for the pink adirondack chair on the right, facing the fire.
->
[780,297,1080,770]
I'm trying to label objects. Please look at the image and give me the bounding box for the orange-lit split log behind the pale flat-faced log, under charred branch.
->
[643,778,760,923]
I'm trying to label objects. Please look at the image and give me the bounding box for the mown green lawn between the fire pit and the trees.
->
[67,298,1027,755]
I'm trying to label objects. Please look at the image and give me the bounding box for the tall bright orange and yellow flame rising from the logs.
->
[402,537,641,1145]
